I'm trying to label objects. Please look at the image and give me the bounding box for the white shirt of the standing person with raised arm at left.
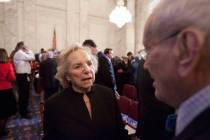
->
[13,49,35,74]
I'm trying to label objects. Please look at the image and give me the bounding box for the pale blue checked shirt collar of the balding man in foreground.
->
[176,85,210,136]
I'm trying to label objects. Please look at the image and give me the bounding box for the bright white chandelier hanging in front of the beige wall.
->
[109,0,132,28]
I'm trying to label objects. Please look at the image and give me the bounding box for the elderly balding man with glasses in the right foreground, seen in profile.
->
[143,0,210,140]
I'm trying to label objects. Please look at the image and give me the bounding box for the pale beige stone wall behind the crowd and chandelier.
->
[0,0,154,56]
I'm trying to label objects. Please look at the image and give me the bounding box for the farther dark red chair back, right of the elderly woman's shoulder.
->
[122,84,137,101]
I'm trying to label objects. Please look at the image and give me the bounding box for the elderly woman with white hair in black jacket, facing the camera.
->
[44,45,129,140]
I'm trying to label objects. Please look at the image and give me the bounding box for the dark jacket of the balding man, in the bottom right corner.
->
[173,107,210,140]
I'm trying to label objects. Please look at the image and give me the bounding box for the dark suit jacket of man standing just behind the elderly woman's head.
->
[95,52,116,90]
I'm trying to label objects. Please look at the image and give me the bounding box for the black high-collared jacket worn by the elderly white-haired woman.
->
[44,85,128,140]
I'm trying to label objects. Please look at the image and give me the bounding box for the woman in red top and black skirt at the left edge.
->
[0,48,17,137]
